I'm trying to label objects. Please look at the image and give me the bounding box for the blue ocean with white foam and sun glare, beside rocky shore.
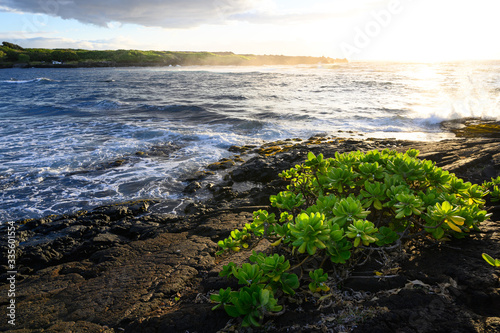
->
[0,61,500,223]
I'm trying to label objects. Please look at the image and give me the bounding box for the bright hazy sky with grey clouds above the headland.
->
[0,0,500,61]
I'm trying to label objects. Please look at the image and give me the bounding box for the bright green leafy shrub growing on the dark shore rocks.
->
[212,149,492,325]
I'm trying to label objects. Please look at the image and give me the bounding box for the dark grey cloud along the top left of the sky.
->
[0,0,263,28]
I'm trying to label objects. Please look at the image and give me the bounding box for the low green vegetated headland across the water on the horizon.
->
[0,42,346,67]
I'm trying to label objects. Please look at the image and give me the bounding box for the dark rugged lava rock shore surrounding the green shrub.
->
[0,137,500,333]
